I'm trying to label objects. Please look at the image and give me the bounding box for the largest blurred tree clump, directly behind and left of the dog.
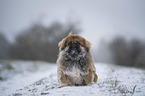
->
[10,22,80,62]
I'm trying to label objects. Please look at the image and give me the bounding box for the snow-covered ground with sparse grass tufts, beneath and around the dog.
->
[0,61,145,96]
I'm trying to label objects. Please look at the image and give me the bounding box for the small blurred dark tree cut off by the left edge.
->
[0,33,10,59]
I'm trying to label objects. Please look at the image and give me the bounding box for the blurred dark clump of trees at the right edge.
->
[109,37,145,67]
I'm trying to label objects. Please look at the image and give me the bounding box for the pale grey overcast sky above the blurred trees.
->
[0,0,145,45]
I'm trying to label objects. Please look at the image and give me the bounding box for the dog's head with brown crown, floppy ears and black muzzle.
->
[58,33,91,55]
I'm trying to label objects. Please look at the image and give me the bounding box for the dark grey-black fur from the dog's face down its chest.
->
[62,41,89,71]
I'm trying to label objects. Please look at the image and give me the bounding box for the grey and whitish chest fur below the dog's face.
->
[62,52,89,78]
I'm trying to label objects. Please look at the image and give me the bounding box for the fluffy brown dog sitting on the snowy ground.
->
[57,33,98,85]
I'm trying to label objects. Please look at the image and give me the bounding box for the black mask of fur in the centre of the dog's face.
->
[68,41,81,55]
